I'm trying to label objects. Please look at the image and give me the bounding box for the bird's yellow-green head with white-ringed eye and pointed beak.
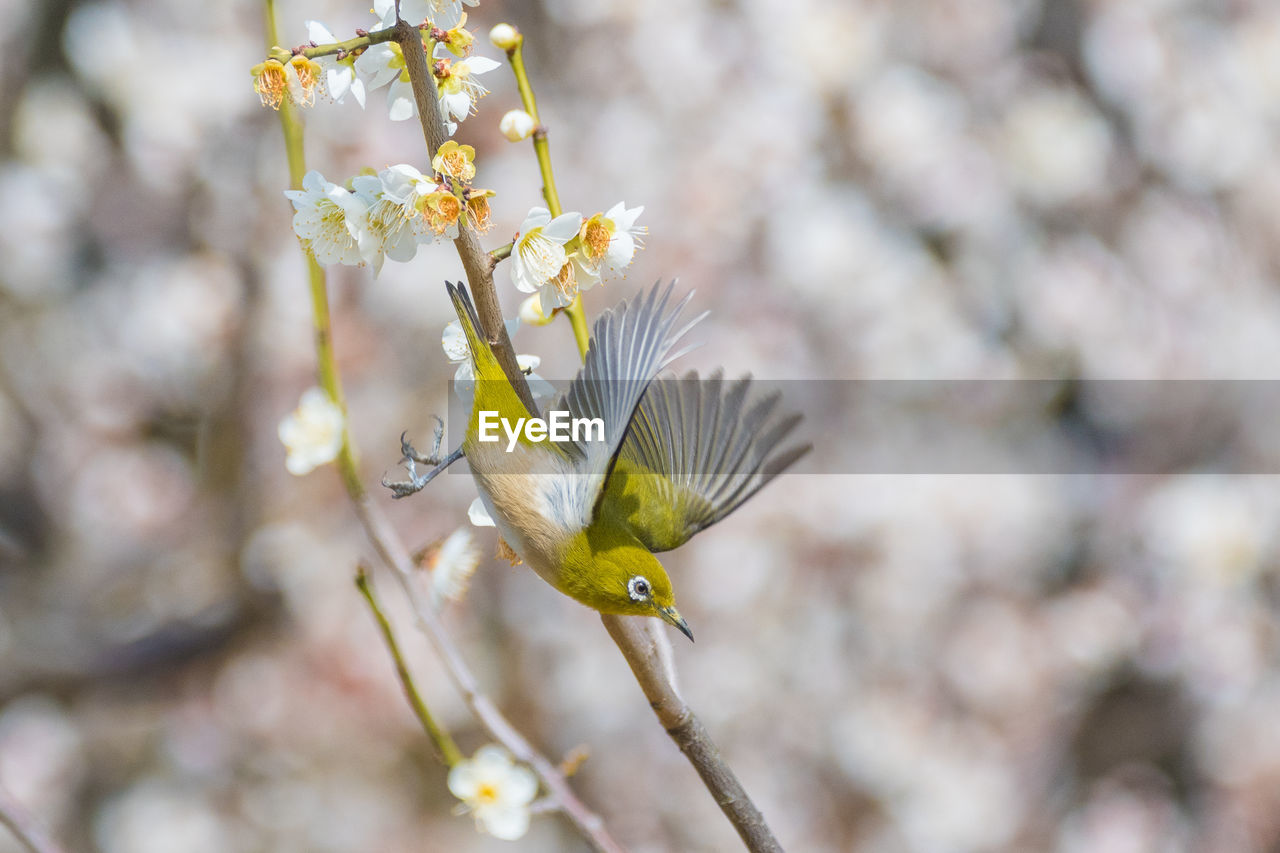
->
[571,532,694,639]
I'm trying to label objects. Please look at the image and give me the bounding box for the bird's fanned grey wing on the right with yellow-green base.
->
[602,371,812,551]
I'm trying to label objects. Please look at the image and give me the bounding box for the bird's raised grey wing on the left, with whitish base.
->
[552,282,707,526]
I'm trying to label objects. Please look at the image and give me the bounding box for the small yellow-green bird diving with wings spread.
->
[406,282,810,639]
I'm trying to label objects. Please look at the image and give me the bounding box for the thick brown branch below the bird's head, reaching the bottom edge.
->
[600,615,782,853]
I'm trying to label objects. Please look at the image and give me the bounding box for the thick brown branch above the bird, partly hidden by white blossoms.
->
[396,20,538,414]
